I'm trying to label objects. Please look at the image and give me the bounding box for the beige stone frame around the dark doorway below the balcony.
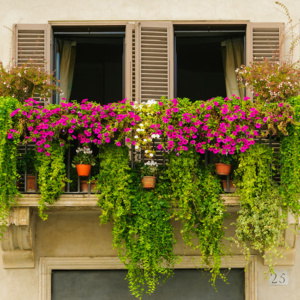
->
[39,255,257,300]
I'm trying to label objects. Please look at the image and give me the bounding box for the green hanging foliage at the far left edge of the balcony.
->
[0,97,20,229]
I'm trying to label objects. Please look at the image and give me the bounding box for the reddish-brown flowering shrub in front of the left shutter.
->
[0,61,60,102]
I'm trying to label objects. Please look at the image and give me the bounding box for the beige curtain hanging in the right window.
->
[221,38,244,98]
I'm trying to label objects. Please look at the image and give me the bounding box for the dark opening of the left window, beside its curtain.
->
[54,27,125,105]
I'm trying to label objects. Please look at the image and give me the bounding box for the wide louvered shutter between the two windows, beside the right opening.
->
[135,22,174,102]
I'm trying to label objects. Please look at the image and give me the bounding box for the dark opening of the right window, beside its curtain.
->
[175,27,245,101]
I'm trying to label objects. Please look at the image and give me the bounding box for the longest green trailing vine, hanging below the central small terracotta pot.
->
[97,147,178,299]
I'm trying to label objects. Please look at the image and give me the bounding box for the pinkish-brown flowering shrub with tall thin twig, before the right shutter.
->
[236,1,300,103]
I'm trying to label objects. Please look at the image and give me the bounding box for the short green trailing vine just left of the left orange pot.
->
[37,142,67,220]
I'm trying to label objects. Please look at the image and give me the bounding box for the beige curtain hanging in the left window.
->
[59,40,76,102]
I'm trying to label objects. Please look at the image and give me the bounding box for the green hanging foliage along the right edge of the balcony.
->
[280,96,300,215]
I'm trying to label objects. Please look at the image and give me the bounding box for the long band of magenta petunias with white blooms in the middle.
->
[7,95,293,157]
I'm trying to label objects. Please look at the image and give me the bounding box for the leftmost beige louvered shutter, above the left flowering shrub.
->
[14,24,51,104]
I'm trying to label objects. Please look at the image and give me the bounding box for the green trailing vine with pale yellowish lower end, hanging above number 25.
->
[235,144,286,268]
